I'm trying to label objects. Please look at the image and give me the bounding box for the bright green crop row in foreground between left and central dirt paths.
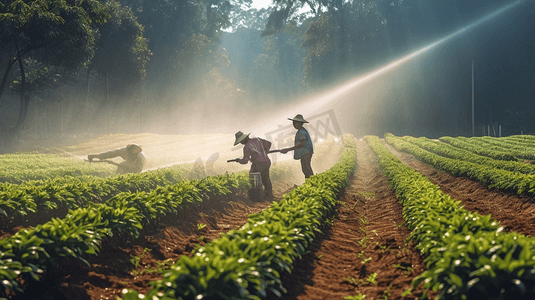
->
[123,135,356,300]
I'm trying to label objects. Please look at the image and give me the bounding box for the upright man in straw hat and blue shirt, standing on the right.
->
[280,114,314,178]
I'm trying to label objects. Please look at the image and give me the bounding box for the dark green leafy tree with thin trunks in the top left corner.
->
[0,0,109,133]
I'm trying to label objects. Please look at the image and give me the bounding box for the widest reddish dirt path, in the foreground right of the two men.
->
[283,141,436,300]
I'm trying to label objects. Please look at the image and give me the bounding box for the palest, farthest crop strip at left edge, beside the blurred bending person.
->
[0,154,116,184]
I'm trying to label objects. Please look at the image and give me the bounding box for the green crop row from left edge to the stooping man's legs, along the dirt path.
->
[0,172,249,295]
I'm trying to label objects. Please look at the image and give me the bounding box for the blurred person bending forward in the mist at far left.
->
[87,144,146,174]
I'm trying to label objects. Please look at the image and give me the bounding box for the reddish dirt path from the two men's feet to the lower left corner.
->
[12,182,294,300]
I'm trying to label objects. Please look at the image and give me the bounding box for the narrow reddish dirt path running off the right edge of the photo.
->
[383,142,535,236]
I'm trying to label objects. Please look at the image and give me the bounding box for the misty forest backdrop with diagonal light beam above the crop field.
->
[0,0,535,152]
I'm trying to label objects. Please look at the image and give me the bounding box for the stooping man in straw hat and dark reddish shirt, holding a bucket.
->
[232,131,273,198]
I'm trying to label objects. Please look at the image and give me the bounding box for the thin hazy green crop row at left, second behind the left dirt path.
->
[0,168,186,224]
